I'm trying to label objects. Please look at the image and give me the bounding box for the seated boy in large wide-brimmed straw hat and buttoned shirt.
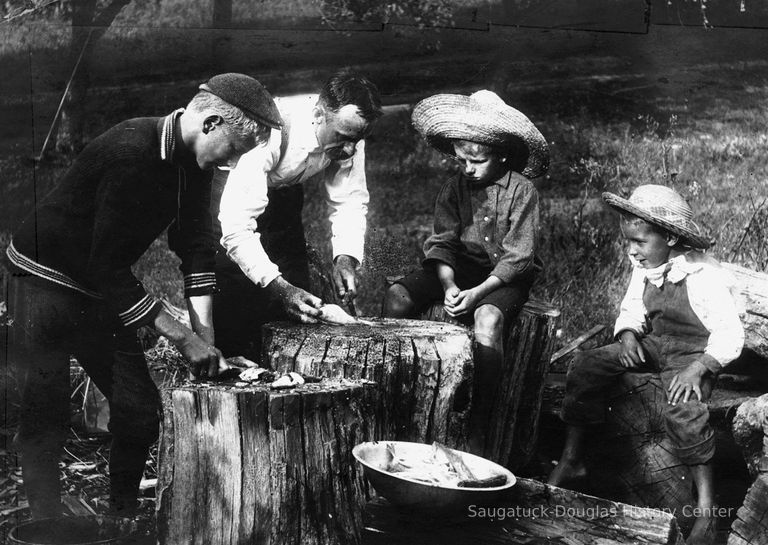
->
[383,91,549,454]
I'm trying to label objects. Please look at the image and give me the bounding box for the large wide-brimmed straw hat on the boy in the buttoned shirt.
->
[412,90,549,178]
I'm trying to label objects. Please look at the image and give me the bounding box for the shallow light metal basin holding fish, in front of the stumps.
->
[352,441,516,513]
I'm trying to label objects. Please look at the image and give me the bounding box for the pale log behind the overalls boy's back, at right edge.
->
[722,263,768,359]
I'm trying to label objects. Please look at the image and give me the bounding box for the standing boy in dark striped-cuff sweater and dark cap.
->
[7,74,281,518]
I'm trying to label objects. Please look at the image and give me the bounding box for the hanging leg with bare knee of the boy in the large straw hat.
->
[469,305,504,455]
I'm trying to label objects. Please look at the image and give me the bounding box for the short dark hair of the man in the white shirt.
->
[320,68,382,122]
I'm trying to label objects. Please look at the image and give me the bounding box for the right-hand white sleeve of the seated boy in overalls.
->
[687,266,744,373]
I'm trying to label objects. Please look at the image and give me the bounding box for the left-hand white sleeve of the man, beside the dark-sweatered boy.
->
[219,135,280,287]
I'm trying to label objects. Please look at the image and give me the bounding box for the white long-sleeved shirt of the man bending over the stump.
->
[219,95,369,287]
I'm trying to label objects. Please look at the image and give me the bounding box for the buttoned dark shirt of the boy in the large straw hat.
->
[424,171,542,283]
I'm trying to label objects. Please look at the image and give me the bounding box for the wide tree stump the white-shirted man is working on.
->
[262,319,472,449]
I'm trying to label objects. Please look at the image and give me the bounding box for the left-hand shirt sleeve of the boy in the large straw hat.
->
[424,181,462,269]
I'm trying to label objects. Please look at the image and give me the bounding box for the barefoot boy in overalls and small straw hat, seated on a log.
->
[549,185,744,543]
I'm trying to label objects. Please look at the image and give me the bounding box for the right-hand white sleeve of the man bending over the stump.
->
[325,140,369,263]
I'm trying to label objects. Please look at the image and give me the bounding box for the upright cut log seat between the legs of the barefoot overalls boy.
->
[586,373,696,526]
